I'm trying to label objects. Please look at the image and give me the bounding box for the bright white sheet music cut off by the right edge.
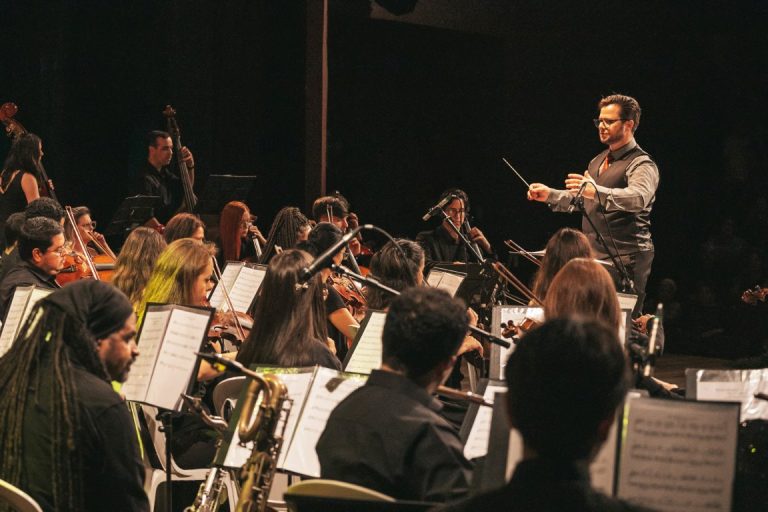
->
[688,368,768,421]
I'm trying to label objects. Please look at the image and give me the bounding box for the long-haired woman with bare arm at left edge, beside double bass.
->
[0,133,43,248]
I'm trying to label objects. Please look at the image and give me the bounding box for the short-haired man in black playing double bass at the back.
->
[135,130,195,227]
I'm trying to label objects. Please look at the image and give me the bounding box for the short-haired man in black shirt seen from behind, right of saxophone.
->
[316,287,472,502]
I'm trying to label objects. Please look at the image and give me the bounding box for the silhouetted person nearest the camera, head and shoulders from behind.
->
[439,319,646,512]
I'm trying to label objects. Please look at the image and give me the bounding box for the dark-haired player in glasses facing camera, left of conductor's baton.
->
[416,189,492,265]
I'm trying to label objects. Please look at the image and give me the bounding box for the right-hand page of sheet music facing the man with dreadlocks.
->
[146,306,211,410]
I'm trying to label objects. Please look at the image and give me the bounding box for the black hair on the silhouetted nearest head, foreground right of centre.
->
[506,318,630,460]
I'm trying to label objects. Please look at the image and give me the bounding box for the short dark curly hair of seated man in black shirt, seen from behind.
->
[382,287,467,379]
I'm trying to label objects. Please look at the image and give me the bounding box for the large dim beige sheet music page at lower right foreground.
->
[617,397,739,512]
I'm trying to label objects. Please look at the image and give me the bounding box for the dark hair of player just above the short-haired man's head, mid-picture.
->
[365,238,424,309]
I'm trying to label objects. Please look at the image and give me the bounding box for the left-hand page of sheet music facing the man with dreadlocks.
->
[123,307,171,402]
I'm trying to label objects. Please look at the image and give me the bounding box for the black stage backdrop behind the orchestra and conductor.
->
[0,0,768,355]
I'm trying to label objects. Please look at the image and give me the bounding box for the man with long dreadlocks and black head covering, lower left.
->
[0,280,149,512]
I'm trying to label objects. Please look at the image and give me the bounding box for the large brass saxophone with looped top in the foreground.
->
[236,373,290,512]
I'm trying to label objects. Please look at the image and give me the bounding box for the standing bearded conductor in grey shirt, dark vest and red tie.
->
[528,94,659,316]
